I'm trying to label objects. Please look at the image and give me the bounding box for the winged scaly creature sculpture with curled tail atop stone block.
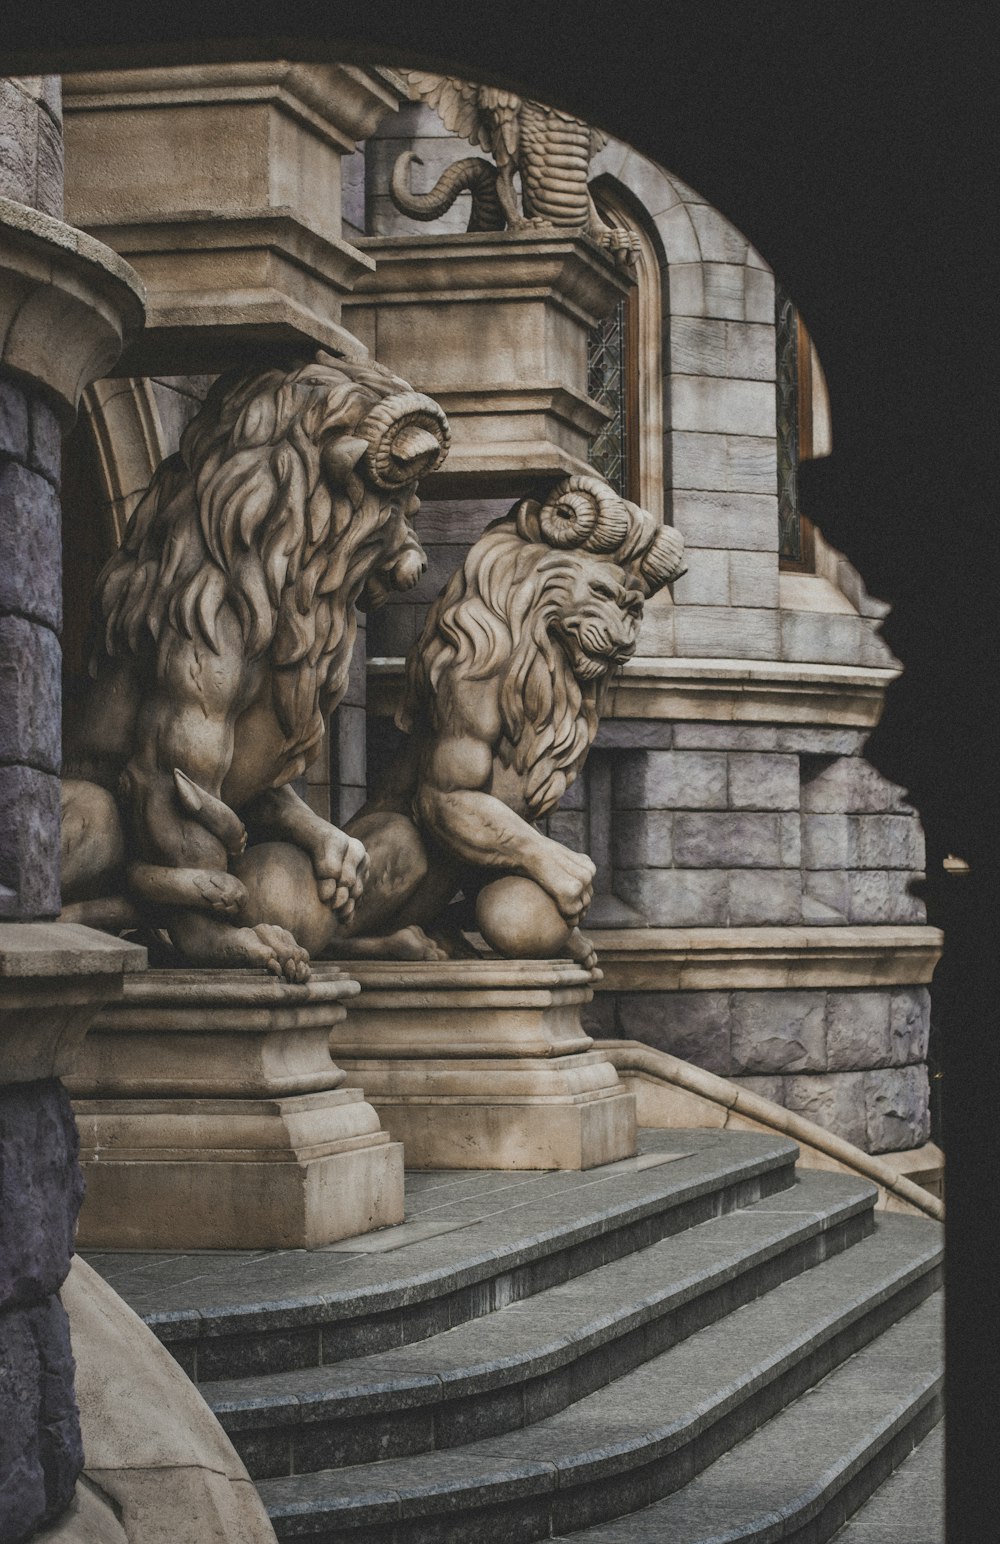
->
[390,69,637,258]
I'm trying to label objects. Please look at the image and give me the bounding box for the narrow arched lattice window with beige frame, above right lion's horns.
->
[588,179,664,519]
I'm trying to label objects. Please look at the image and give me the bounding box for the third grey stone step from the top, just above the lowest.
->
[258,1217,940,1544]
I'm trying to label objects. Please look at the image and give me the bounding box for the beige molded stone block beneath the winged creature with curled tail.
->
[343,232,631,497]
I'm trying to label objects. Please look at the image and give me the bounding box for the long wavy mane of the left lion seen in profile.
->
[91,354,446,772]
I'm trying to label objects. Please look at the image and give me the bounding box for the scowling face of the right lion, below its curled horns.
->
[549,553,642,681]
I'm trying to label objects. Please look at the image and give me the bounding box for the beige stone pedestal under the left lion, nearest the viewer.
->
[66,970,403,1249]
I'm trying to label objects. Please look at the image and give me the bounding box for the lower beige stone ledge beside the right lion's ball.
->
[585,923,943,991]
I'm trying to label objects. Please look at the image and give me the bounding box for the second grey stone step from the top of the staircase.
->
[202,1172,876,1479]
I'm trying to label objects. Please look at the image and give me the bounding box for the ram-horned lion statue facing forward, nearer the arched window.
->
[238,476,684,967]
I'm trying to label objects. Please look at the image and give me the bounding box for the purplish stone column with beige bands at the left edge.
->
[0,77,145,1544]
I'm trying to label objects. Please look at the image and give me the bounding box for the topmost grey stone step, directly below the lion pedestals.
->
[85,1130,798,1382]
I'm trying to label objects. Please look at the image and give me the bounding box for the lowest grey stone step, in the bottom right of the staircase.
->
[556,1297,944,1544]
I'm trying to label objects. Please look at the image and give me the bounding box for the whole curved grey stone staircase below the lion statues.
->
[88,1130,943,1544]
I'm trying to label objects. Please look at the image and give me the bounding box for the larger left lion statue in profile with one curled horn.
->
[62,352,448,980]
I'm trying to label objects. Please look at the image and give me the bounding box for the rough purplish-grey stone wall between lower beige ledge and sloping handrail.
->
[614,987,931,1152]
